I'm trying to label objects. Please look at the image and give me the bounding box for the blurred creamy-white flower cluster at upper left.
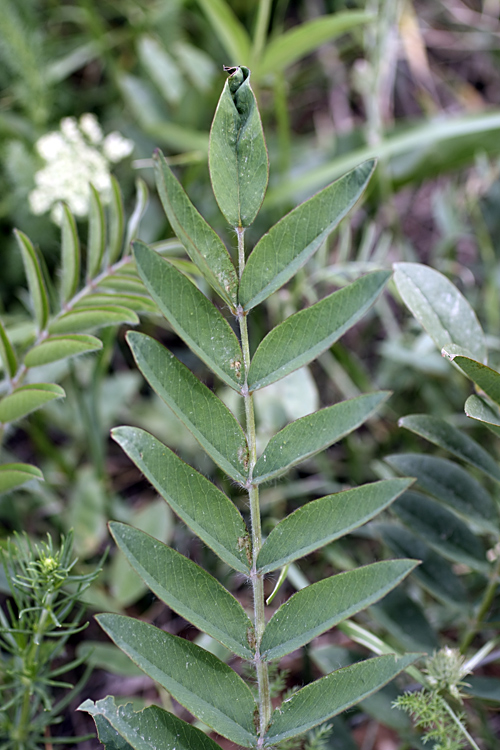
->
[29,113,134,224]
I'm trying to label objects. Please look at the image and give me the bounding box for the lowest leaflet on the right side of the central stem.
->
[266,654,419,745]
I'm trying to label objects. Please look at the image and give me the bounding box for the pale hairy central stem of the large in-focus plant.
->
[236,227,271,748]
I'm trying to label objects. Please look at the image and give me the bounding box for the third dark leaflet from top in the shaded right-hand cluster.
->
[392,491,490,573]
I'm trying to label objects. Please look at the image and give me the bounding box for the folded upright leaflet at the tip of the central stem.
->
[208,67,269,229]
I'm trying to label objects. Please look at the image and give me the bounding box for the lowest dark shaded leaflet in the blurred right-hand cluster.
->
[370,589,439,654]
